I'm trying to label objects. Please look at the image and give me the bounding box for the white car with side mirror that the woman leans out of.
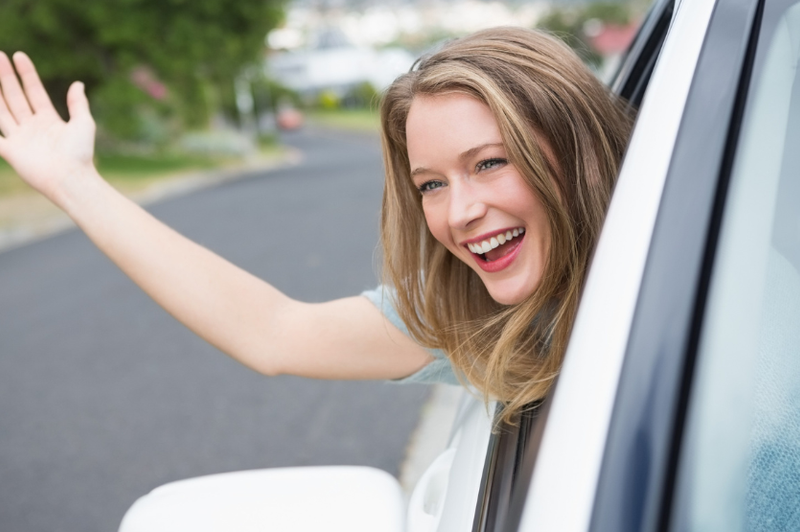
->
[121,0,800,532]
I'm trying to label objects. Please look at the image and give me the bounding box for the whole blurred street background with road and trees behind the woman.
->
[0,0,648,532]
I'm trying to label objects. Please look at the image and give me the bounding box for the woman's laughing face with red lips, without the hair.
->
[406,93,550,305]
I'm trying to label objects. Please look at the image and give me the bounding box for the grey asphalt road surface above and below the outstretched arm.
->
[0,129,428,532]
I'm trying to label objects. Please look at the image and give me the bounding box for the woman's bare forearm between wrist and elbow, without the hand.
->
[58,169,293,374]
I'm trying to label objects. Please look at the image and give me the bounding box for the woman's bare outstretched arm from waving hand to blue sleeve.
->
[0,52,430,379]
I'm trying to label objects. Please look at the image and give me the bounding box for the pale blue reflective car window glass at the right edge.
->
[671,1,800,532]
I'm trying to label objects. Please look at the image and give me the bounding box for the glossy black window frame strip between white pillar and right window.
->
[590,0,762,532]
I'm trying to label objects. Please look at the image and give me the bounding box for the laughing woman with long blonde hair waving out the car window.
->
[0,28,630,432]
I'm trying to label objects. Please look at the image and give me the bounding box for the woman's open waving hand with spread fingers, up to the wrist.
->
[0,52,95,200]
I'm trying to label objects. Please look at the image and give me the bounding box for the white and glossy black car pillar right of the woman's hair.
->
[507,0,761,532]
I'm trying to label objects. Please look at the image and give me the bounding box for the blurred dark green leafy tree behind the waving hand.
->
[0,0,285,142]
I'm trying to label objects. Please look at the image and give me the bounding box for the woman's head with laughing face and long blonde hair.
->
[381,28,631,421]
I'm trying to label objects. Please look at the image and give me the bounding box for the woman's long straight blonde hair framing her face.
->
[381,28,631,421]
